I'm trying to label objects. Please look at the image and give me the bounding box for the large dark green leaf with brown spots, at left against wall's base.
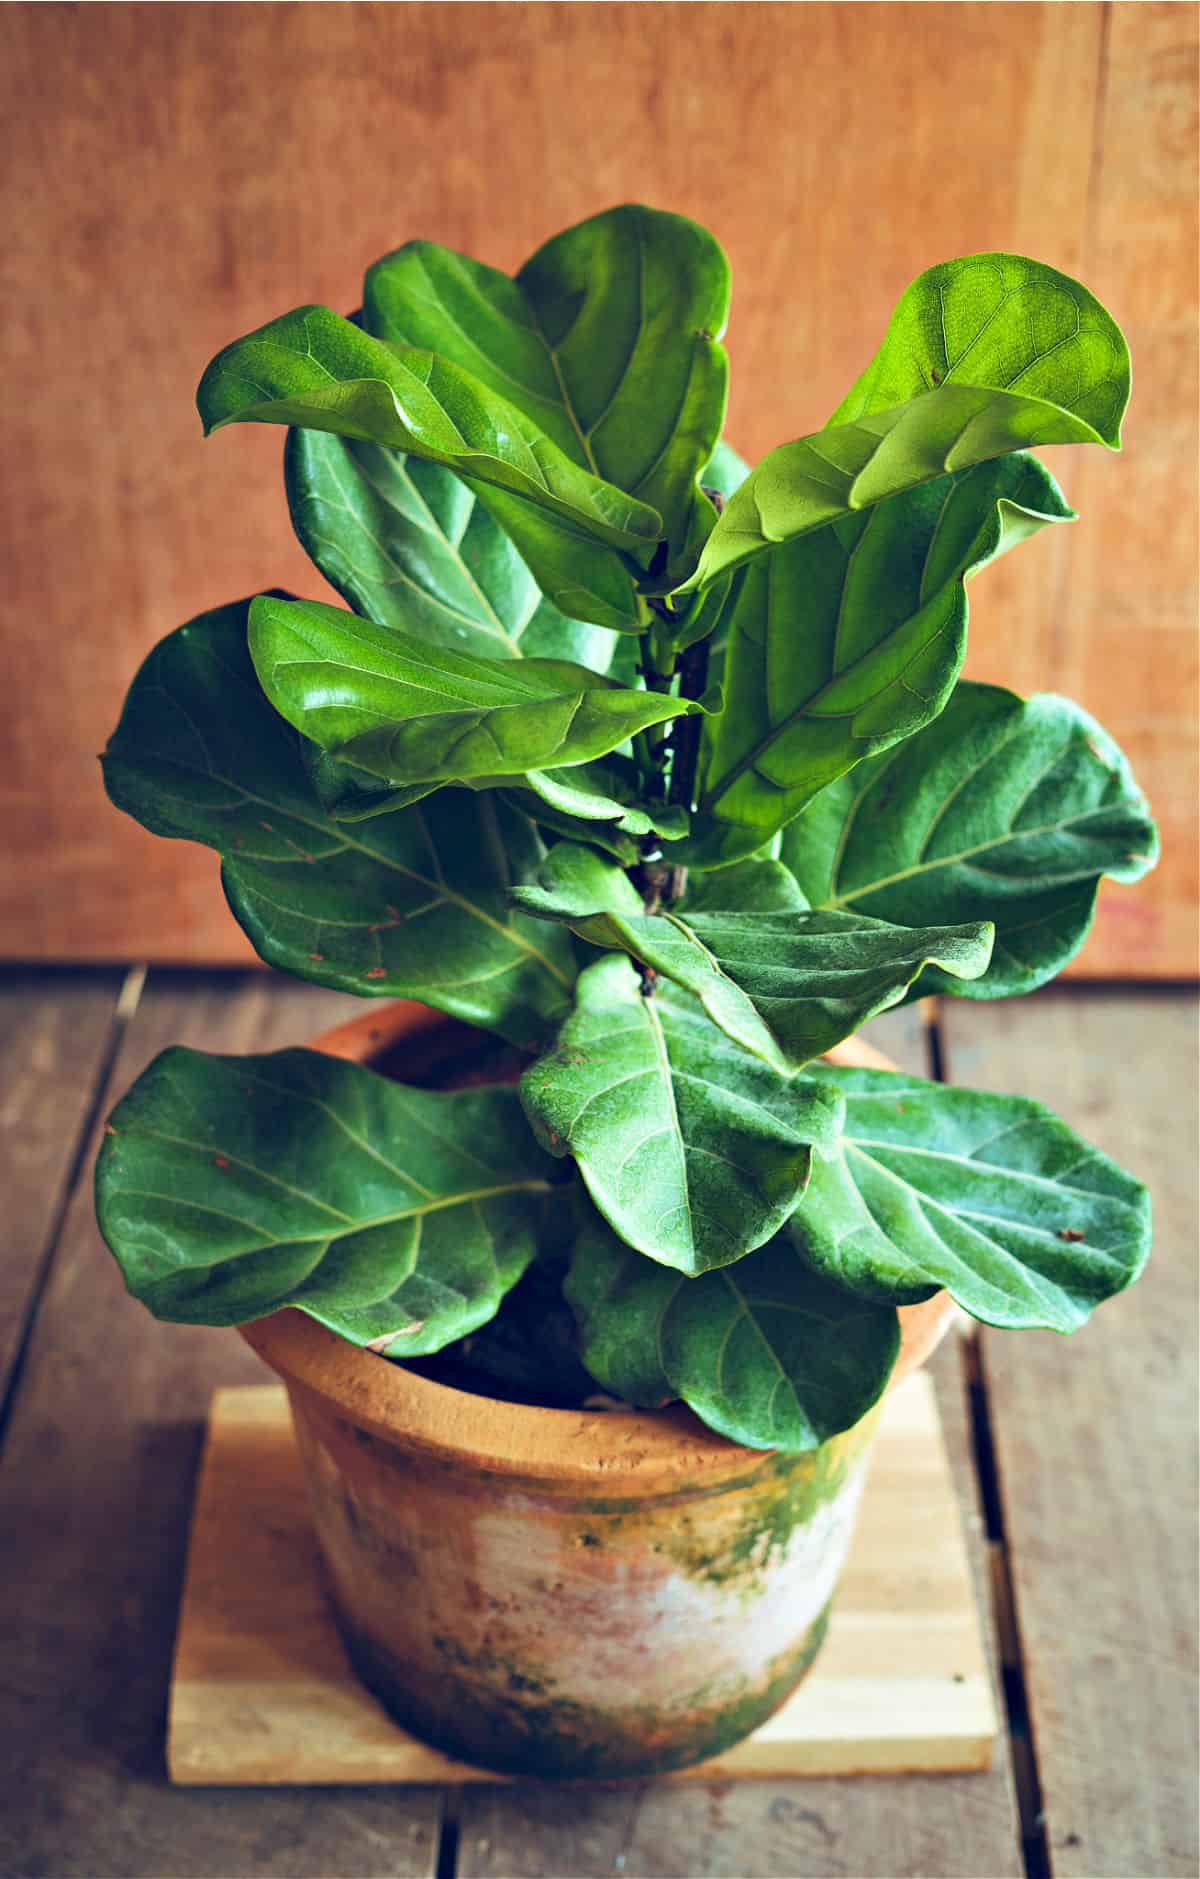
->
[103,601,575,1043]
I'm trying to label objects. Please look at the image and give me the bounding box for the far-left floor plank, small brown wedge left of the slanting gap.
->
[0,970,122,1400]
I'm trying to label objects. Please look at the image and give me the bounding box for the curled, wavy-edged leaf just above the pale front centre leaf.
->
[513,844,993,1071]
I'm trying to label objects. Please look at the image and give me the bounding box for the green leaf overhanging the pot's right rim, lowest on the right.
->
[789,1065,1149,1330]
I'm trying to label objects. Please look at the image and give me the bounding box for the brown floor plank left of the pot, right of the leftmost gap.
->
[0,975,439,1879]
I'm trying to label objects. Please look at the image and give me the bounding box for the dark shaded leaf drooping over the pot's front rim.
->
[565,1221,900,1452]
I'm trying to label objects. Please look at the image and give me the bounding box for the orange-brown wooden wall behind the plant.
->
[0,0,1196,977]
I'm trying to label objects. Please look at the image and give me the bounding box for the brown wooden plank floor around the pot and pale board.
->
[0,971,1198,1879]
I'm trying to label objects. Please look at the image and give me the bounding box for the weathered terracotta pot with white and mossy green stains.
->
[242,1003,954,1778]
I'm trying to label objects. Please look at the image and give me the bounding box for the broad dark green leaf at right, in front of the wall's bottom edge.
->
[784,682,1159,998]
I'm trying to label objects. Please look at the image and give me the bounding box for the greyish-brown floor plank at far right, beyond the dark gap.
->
[945,988,1198,1879]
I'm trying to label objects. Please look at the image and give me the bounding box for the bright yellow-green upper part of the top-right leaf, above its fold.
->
[830,254,1129,437]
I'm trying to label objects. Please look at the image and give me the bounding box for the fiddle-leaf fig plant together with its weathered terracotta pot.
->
[98,207,1157,1776]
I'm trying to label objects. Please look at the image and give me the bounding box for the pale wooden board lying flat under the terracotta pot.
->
[167,1375,997,1787]
